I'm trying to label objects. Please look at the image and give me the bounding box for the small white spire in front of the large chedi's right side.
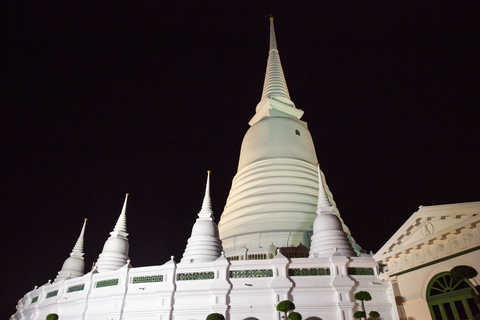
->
[309,164,356,258]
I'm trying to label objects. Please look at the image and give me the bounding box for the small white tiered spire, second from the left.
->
[96,193,129,272]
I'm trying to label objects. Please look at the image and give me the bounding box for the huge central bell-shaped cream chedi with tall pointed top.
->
[218,18,349,259]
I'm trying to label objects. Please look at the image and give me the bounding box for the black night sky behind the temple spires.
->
[0,1,480,319]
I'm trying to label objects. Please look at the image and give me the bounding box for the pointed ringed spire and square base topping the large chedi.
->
[249,17,303,126]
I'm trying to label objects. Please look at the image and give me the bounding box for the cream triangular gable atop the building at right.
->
[374,201,480,261]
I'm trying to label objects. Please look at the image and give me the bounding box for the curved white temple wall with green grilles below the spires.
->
[16,254,398,320]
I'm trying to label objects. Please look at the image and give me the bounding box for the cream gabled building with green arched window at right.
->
[375,202,480,320]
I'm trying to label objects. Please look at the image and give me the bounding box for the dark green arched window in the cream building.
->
[427,272,480,320]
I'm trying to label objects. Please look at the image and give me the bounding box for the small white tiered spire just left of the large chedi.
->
[181,171,222,263]
